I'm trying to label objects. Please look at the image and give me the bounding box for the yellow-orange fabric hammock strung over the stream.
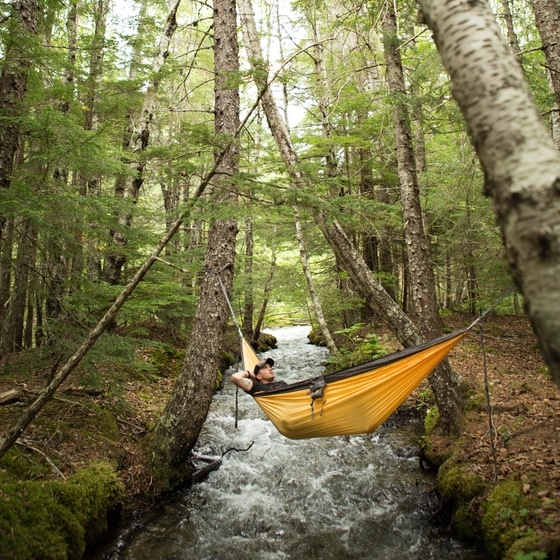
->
[241,325,472,439]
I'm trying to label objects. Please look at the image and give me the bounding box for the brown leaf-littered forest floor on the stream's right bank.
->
[424,315,560,560]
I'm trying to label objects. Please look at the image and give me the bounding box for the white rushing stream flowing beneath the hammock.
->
[94,327,472,560]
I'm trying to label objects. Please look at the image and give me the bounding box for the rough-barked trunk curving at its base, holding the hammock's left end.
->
[151,0,239,487]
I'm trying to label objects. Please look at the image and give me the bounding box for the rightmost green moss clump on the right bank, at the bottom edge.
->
[482,480,539,558]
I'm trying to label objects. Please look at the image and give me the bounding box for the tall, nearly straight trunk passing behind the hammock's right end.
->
[383,2,465,434]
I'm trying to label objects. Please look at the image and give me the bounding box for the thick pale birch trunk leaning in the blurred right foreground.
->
[419,0,560,384]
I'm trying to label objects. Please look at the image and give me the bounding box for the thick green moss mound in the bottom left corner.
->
[0,464,123,560]
